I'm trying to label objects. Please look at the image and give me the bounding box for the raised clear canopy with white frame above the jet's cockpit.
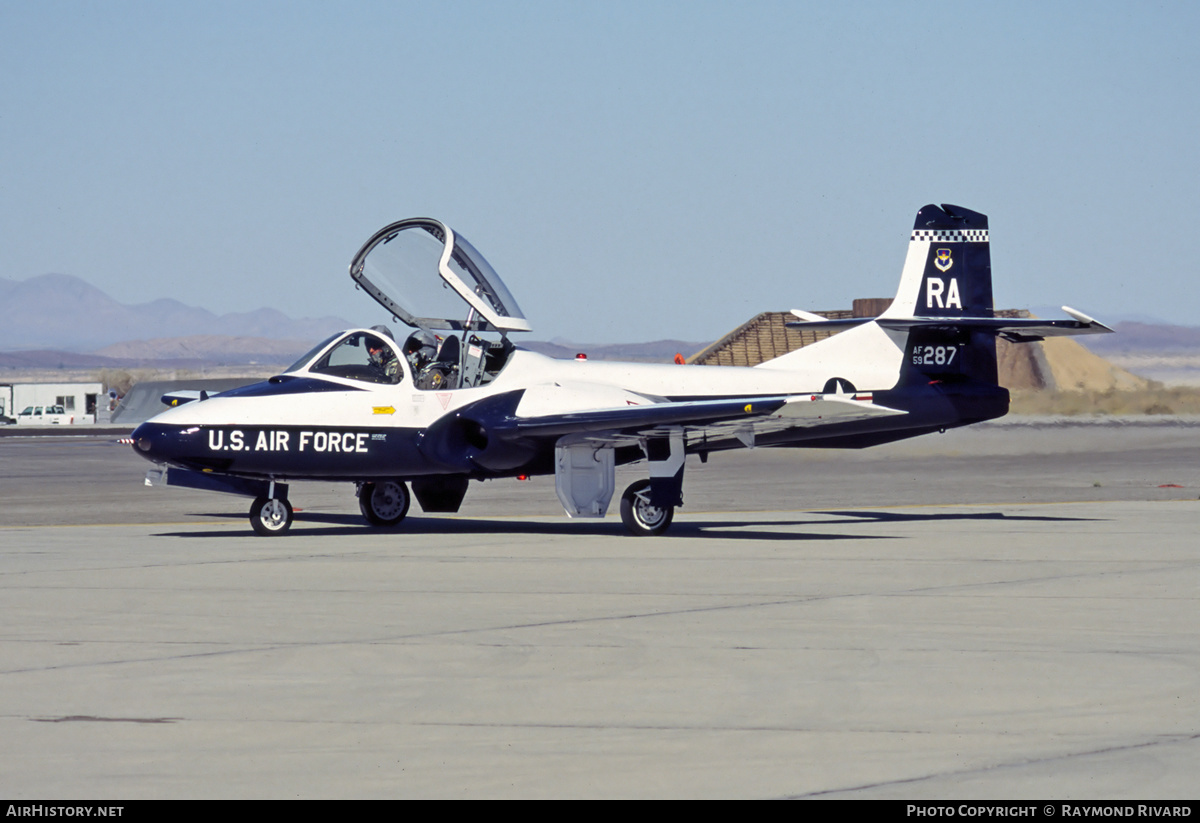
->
[350,217,529,331]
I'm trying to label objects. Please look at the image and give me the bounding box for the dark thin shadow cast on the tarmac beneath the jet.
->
[150,511,1094,540]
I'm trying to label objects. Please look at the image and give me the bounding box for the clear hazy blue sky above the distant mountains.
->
[0,0,1200,342]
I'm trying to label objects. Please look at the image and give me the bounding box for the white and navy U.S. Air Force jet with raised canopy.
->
[132,205,1111,535]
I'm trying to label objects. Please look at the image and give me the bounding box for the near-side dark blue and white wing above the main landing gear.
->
[516,395,906,441]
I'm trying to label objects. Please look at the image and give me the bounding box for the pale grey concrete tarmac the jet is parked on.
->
[0,420,1200,799]
